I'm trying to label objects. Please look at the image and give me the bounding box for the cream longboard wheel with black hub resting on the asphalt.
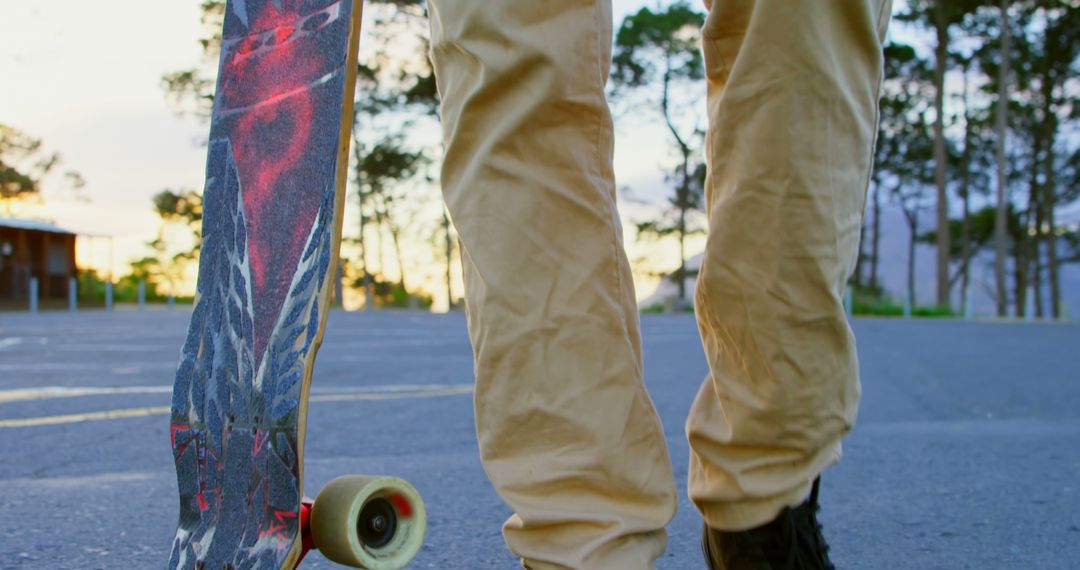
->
[311,475,428,570]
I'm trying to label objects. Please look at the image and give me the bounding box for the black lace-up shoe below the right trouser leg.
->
[701,478,835,570]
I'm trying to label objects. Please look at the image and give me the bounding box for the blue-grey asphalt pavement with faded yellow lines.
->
[0,309,1080,570]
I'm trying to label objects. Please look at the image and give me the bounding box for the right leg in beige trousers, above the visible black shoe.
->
[686,0,891,531]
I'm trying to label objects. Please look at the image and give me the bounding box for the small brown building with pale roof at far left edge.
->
[0,218,78,303]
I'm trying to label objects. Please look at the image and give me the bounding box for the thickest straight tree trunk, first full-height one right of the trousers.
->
[934,1,950,307]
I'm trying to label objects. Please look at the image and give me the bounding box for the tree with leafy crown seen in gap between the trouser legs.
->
[611,1,705,301]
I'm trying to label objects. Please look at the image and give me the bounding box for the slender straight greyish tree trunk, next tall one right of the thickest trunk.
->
[994,0,1010,316]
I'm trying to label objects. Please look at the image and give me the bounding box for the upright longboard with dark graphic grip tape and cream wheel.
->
[168,0,424,570]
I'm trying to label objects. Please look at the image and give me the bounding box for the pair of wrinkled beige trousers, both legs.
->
[430,0,890,570]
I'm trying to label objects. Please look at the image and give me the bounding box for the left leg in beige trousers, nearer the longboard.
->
[430,0,677,570]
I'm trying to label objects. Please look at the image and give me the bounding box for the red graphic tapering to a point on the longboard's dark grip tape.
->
[215,0,341,361]
